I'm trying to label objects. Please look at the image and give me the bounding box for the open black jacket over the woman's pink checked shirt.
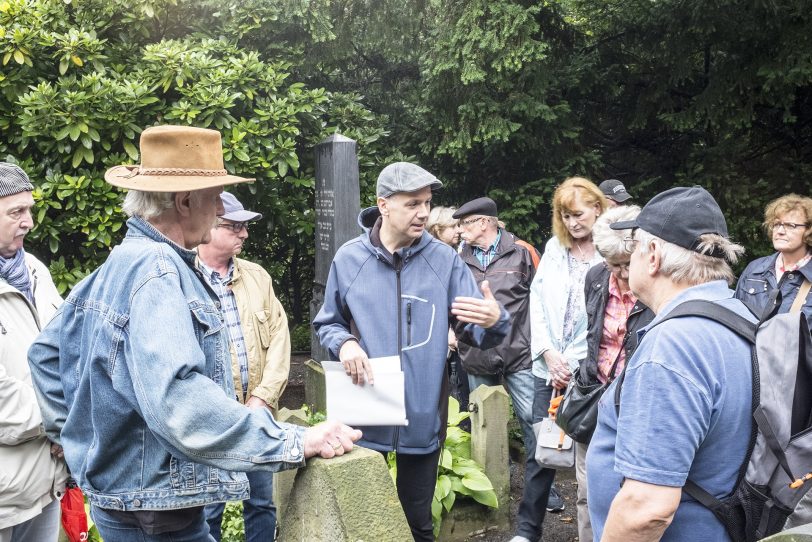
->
[579,263,654,384]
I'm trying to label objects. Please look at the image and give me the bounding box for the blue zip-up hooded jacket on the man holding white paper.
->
[313,207,510,454]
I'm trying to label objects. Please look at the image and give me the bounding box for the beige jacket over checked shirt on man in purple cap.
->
[231,258,290,414]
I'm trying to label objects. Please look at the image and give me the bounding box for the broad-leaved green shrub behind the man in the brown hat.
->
[0,0,386,323]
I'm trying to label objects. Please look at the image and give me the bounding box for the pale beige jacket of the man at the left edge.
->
[0,254,68,529]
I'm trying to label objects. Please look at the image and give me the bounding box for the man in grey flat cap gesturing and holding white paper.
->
[313,162,510,541]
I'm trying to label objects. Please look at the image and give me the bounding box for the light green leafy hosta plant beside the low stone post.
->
[387,397,499,537]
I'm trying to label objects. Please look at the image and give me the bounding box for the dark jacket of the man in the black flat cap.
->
[455,230,535,375]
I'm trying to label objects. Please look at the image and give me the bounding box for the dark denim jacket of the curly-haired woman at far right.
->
[736,252,812,330]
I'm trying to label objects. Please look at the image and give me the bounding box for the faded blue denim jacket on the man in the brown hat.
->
[29,218,304,511]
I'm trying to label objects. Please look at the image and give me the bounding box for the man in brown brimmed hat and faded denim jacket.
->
[29,126,360,542]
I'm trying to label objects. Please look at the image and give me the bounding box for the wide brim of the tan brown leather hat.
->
[104,166,256,192]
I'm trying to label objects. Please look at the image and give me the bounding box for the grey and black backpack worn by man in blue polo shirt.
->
[615,300,812,542]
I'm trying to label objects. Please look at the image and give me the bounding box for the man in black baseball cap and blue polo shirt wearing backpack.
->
[586,186,755,541]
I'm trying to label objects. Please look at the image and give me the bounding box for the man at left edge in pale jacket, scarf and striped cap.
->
[0,162,68,542]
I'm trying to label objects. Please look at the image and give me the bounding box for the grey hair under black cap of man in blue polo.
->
[635,228,744,286]
